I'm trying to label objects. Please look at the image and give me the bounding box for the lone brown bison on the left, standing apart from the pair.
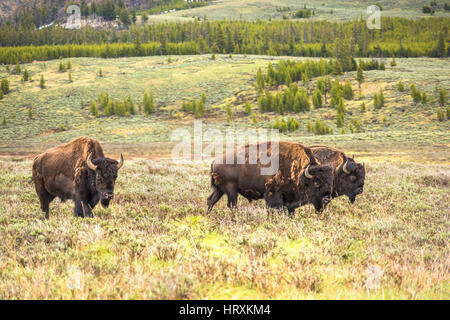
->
[33,137,123,219]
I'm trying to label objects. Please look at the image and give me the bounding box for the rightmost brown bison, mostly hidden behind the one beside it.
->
[310,146,366,203]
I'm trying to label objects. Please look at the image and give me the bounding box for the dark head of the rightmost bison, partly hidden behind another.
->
[335,158,366,203]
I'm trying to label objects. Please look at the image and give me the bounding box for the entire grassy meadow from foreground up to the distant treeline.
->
[0,51,450,299]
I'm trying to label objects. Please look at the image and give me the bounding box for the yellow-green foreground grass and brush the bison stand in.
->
[0,156,450,299]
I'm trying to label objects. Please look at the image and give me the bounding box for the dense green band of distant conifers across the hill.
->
[0,17,450,63]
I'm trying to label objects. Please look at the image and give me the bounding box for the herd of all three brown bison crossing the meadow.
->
[33,137,366,219]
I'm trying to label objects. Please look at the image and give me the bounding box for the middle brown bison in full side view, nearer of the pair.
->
[207,141,333,214]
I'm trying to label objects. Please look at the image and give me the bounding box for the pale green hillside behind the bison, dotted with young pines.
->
[0,55,450,153]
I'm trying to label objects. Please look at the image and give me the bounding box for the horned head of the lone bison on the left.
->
[86,154,123,208]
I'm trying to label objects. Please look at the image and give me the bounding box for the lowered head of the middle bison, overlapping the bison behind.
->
[302,164,334,212]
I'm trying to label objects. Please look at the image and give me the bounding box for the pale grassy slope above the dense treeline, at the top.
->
[153,0,448,23]
